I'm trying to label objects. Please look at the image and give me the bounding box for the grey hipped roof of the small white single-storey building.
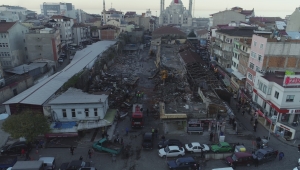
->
[49,88,108,104]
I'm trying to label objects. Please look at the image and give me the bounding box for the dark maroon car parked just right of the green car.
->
[225,152,254,168]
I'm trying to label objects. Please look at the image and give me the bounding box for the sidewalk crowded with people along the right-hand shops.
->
[230,98,298,147]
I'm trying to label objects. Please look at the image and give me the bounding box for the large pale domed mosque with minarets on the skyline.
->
[159,0,193,27]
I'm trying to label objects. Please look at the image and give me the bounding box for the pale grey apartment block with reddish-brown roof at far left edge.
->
[0,22,28,69]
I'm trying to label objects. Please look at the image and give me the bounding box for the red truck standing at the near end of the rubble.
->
[131,104,144,128]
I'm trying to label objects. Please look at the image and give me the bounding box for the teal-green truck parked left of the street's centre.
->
[93,138,123,155]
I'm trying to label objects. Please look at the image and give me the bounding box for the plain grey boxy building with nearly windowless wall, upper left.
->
[25,28,61,62]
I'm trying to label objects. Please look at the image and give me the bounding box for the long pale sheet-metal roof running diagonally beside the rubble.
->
[3,41,116,105]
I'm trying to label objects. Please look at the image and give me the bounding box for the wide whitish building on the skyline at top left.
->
[40,2,75,17]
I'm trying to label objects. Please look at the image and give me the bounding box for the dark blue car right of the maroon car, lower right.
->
[252,147,278,163]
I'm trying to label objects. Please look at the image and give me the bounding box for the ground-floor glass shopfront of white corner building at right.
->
[275,122,296,140]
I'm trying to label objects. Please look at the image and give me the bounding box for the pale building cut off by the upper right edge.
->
[285,7,300,32]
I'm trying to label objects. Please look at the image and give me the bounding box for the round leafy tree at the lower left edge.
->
[2,110,50,142]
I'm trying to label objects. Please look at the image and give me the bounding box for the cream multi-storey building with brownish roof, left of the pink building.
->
[212,27,255,68]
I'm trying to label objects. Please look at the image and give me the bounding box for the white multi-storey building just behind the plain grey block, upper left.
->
[49,15,74,47]
